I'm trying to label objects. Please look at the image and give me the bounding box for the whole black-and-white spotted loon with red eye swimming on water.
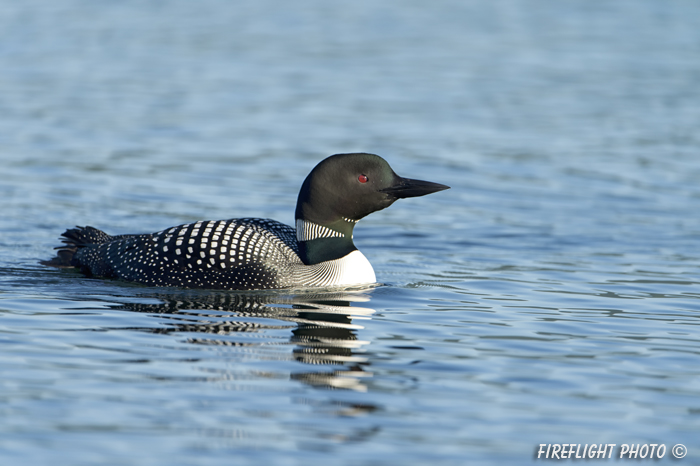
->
[41,153,449,290]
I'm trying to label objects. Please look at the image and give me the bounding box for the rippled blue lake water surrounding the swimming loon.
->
[0,0,700,465]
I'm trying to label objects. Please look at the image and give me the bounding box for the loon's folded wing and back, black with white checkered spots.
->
[64,218,301,290]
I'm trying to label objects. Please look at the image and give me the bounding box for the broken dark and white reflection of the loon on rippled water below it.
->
[111,290,376,396]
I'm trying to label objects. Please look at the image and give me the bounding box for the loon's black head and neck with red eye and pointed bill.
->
[295,153,449,264]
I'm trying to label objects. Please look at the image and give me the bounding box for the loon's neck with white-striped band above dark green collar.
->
[296,218,357,265]
